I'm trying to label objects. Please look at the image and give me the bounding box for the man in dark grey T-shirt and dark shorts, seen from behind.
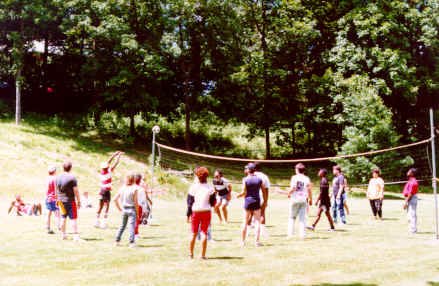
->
[56,162,81,241]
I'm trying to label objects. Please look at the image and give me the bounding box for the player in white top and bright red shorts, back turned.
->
[186,167,216,260]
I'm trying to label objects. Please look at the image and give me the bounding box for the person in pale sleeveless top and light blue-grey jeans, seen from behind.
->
[114,173,139,247]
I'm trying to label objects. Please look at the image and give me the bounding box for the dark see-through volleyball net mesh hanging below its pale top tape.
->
[156,139,432,187]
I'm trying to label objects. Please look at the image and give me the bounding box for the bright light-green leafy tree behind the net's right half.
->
[334,76,414,183]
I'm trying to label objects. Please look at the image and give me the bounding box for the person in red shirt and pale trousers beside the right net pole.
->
[402,168,419,234]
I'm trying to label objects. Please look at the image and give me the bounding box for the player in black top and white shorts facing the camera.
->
[212,169,232,224]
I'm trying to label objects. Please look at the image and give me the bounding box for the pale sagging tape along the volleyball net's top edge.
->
[156,138,431,164]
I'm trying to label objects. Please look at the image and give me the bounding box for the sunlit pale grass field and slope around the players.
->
[0,116,439,285]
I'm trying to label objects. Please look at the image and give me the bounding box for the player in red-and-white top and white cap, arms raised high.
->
[95,151,123,228]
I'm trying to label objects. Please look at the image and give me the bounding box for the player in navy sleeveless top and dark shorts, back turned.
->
[237,163,268,246]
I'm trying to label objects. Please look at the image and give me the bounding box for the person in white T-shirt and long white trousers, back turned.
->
[287,163,312,238]
